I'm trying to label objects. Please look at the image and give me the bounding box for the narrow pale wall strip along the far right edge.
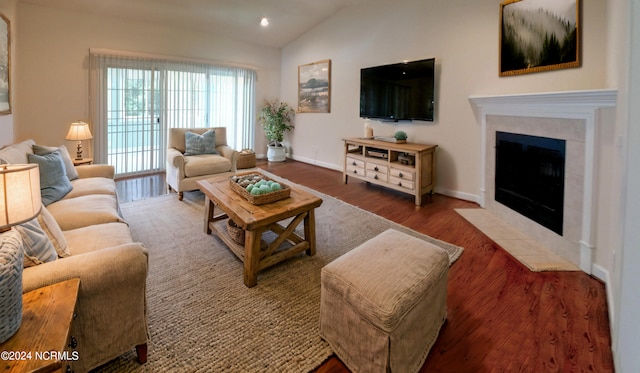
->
[609,0,640,373]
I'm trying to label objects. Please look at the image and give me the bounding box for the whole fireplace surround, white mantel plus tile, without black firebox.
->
[470,90,616,273]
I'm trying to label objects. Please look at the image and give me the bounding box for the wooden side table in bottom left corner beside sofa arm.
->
[0,278,80,373]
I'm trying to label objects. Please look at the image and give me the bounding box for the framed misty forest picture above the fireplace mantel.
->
[500,0,580,76]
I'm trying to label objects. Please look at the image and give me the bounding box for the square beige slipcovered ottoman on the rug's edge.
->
[320,229,449,373]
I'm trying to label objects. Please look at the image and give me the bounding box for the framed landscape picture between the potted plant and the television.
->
[298,60,331,113]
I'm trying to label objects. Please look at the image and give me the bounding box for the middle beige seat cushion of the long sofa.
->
[47,194,123,232]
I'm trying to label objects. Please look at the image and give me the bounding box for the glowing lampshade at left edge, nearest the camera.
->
[0,164,42,232]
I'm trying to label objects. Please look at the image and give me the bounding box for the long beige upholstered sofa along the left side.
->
[0,140,148,372]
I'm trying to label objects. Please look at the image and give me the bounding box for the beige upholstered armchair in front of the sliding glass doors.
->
[167,127,239,200]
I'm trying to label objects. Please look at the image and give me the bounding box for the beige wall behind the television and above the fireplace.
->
[281,0,607,200]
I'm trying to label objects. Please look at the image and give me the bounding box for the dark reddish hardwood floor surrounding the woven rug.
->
[118,160,614,373]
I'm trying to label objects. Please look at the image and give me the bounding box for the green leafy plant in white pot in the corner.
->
[258,101,295,162]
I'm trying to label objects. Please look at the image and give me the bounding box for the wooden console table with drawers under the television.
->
[343,138,438,206]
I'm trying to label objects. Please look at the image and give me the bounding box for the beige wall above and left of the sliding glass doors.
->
[14,2,280,153]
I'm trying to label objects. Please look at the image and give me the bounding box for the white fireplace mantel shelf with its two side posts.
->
[469,89,617,273]
